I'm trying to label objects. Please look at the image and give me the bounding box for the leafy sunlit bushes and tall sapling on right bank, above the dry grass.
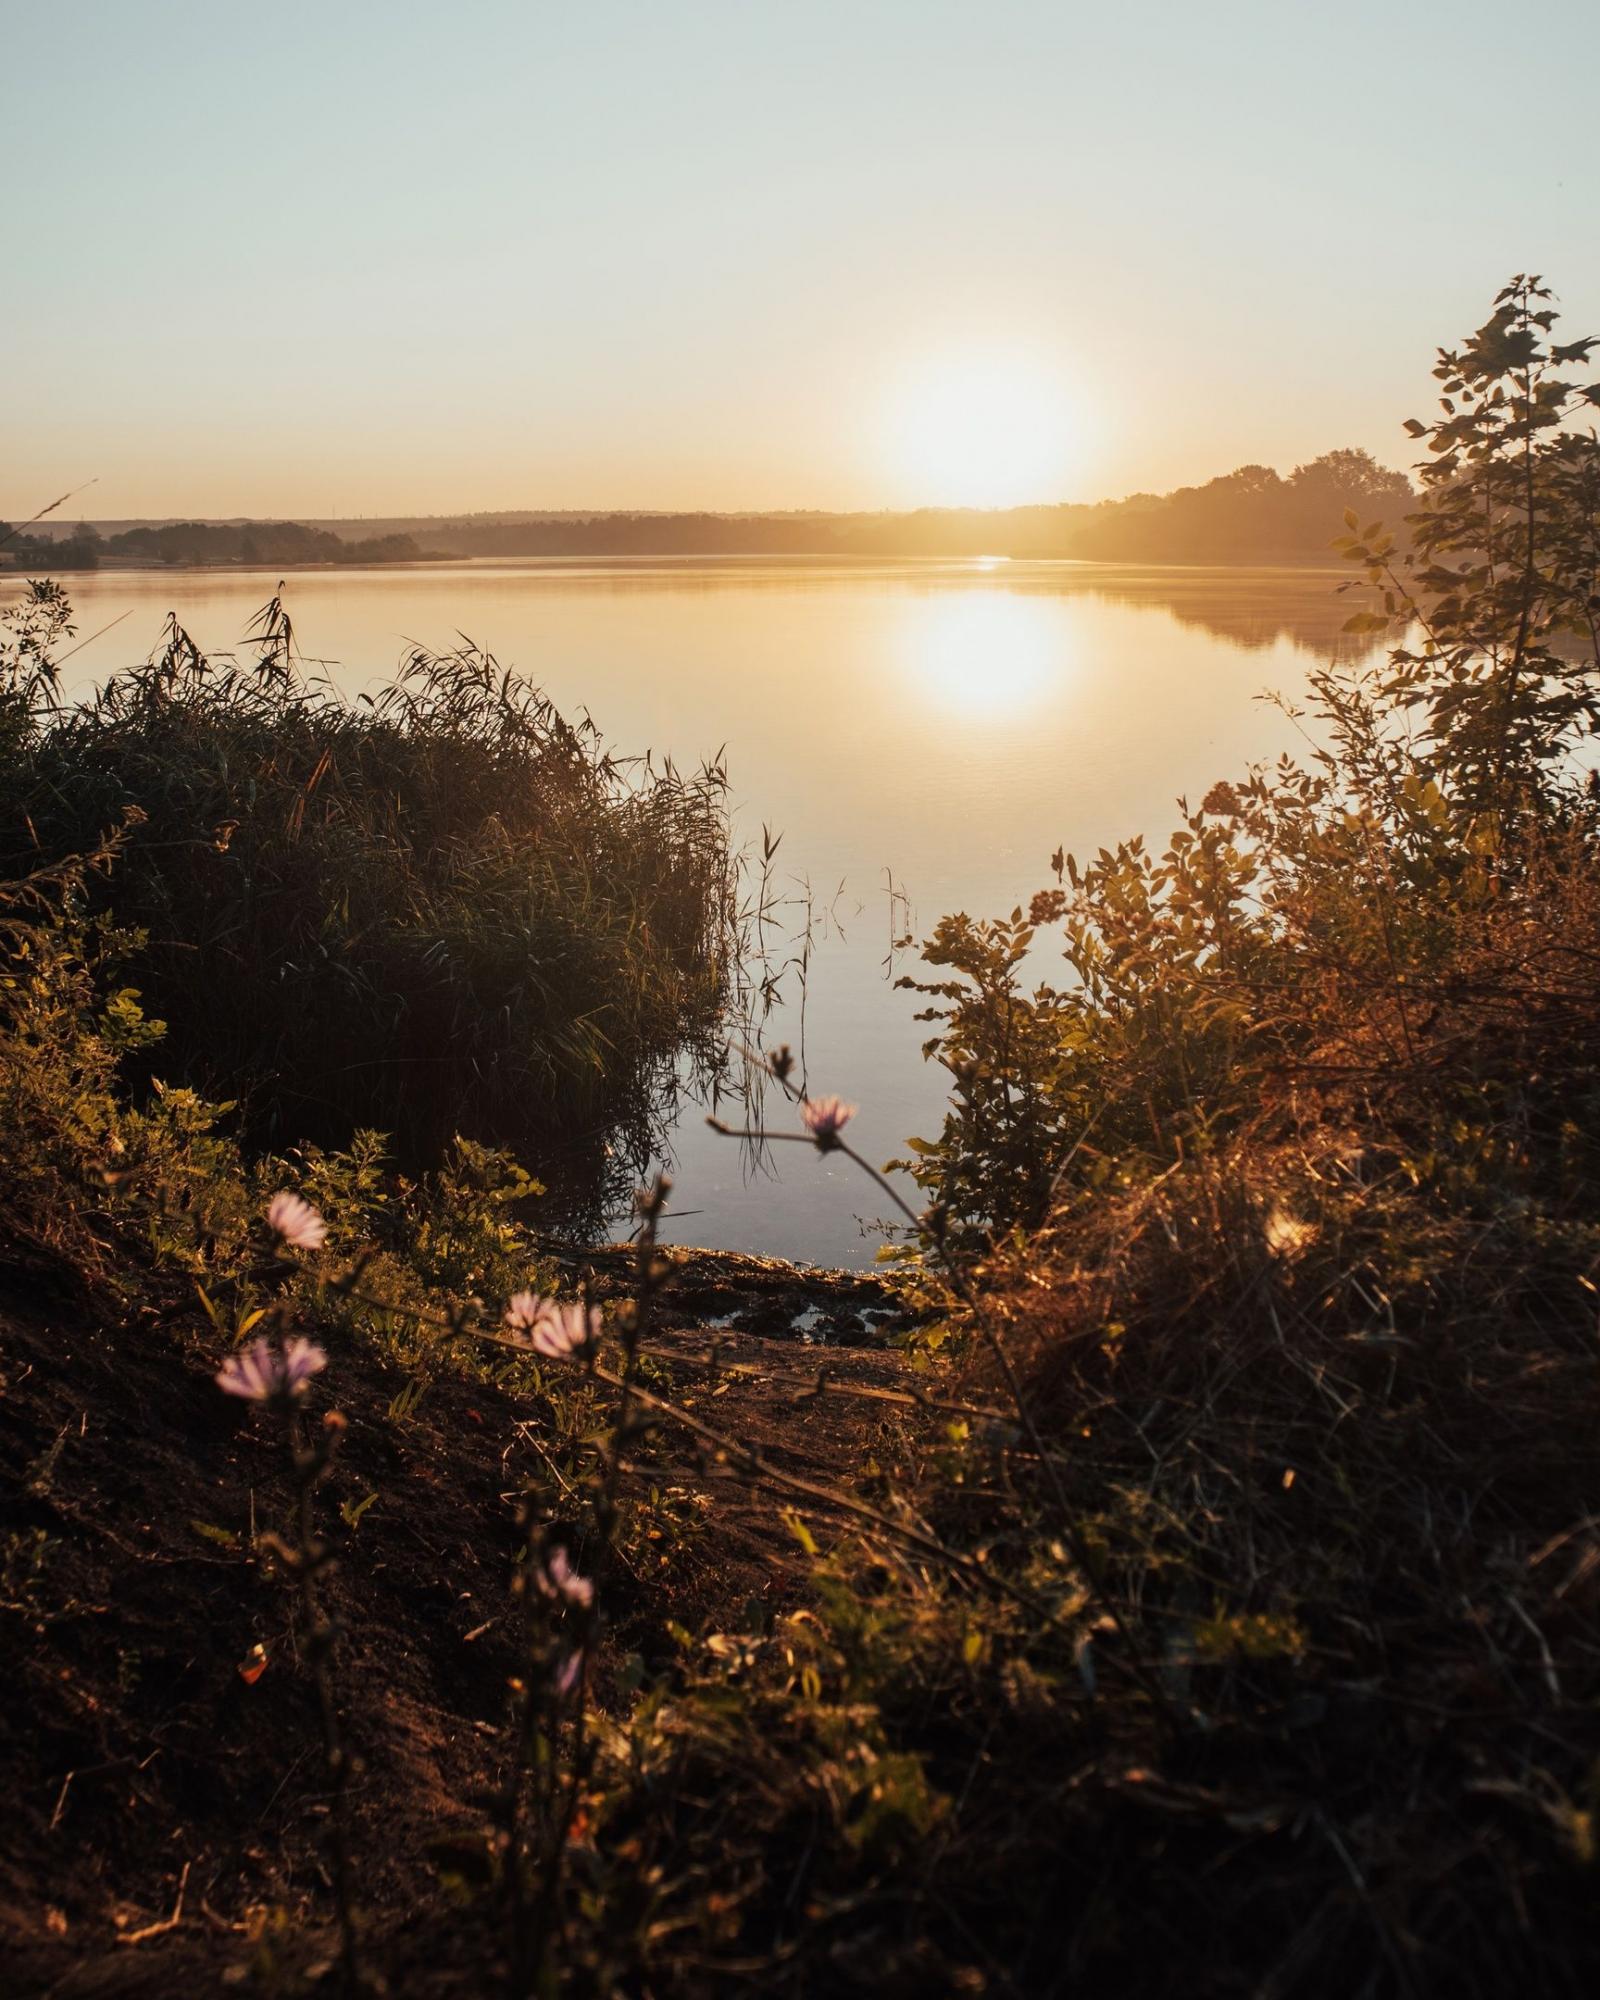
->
[892,280,1600,1250]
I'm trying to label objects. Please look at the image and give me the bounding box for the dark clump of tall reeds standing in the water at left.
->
[0,584,736,1216]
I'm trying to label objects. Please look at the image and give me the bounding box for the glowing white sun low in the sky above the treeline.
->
[886,352,1086,506]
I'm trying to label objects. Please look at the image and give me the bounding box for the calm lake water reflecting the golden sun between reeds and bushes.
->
[47,560,1376,1264]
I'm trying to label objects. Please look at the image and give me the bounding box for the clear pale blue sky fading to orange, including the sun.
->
[0,0,1600,518]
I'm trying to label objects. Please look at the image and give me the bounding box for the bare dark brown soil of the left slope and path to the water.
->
[0,1250,916,2000]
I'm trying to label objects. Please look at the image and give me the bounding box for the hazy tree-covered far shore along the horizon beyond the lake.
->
[0,450,1414,568]
